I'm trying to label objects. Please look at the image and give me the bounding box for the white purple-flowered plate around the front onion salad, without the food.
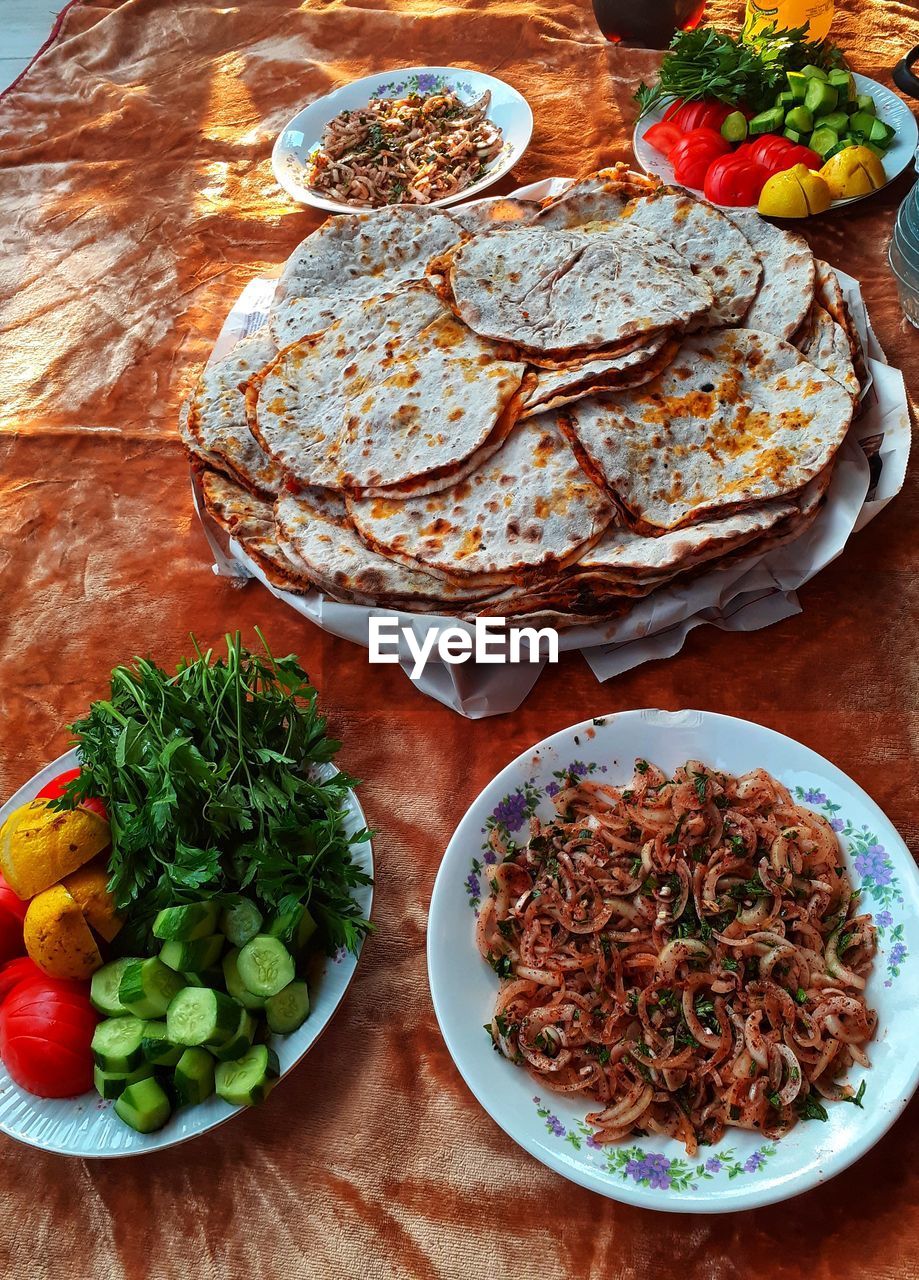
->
[428,710,919,1213]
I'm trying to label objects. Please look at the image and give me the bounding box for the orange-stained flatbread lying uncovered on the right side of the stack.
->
[561,329,852,534]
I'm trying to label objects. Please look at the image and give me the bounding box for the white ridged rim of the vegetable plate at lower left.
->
[0,750,374,1160]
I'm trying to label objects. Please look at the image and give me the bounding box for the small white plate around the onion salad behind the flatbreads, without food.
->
[271,67,532,214]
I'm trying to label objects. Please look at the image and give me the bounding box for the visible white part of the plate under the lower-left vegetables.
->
[0,751,374,1157]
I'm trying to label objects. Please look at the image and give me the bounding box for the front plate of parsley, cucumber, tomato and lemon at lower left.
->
[0,635,372,1157]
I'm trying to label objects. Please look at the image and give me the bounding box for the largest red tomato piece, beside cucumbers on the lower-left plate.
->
[0,979,99,1098]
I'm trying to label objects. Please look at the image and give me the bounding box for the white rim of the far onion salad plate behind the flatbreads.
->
[271,67,532,214]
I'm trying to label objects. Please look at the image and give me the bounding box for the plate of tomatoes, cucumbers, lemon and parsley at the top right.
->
[632,28,919,218]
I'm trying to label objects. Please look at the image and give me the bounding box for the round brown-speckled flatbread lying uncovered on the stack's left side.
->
[247,284,526,490]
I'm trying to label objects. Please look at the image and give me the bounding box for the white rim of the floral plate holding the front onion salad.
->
[428,709,919,1213]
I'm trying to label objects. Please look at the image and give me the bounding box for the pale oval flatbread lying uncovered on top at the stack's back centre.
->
[430,220,714,355]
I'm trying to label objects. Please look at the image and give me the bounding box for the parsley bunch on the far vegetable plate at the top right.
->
[635,24,842,119]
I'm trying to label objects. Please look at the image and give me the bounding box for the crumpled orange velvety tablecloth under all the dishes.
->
[0,0,919,1280]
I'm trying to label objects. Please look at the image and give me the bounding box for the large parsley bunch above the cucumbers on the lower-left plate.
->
[58,628,371,951]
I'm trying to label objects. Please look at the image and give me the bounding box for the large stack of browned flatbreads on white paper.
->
[180,166,864,626]
